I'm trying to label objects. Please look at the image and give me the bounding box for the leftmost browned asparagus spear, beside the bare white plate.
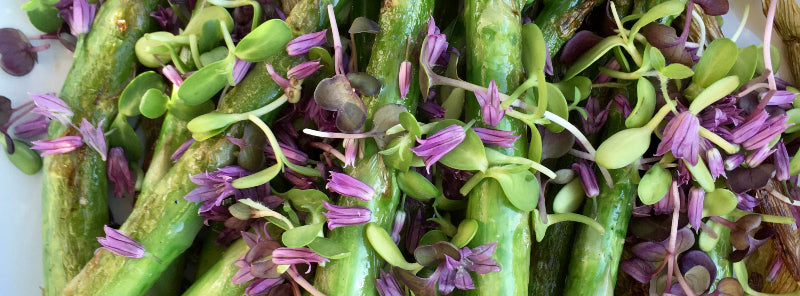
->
[42,0,162,295]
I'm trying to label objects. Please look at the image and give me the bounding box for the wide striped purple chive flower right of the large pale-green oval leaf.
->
[656,111,700,165]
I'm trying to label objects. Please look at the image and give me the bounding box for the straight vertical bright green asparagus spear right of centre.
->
[463,0,531,295]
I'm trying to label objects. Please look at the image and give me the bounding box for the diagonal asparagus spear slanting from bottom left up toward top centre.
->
[57,0,347,295]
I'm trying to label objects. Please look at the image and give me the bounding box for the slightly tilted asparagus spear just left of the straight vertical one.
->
[314,0,434,296]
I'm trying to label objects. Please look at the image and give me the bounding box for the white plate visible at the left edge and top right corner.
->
[0,0,792,295]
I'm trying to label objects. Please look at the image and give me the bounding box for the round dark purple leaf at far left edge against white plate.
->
[0,28,38,76]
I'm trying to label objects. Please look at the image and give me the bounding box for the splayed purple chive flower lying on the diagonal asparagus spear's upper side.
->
[183,165,250,213]
